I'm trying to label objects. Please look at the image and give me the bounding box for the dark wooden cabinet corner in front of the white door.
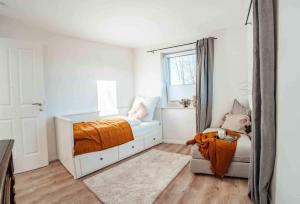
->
[0,140,15,204]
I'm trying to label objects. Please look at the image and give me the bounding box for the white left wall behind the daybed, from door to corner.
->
[0,16,134,160]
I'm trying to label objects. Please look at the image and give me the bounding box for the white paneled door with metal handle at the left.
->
[0,38,48,173]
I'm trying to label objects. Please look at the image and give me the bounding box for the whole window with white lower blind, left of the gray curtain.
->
[163,50,196,103]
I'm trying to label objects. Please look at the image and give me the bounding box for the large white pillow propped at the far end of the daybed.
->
[131,96,159,121]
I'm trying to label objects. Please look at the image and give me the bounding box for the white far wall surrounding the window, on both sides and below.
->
[134,25,248,143]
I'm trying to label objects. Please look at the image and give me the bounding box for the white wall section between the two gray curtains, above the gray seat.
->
[212,25,248,126]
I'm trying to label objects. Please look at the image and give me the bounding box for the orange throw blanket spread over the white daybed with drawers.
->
[73,118,133,155]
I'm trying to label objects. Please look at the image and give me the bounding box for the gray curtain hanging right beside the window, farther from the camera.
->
[196,38,214,132]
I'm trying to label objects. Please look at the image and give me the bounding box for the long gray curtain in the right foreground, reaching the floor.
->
[249,0,276,204]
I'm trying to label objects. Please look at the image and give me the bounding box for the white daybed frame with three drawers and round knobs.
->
[55,108,162,179]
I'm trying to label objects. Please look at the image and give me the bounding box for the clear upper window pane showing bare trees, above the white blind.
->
[168,54,196,86]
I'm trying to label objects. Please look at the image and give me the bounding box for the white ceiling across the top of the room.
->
[0,0,248,47]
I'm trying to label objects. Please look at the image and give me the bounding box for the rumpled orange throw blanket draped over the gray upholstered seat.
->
[187,130,240,178]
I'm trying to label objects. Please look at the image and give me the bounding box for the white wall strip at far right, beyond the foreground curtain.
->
[275,0,300,204]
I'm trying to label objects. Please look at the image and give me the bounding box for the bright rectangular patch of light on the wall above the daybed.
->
[97,80,118,116]
